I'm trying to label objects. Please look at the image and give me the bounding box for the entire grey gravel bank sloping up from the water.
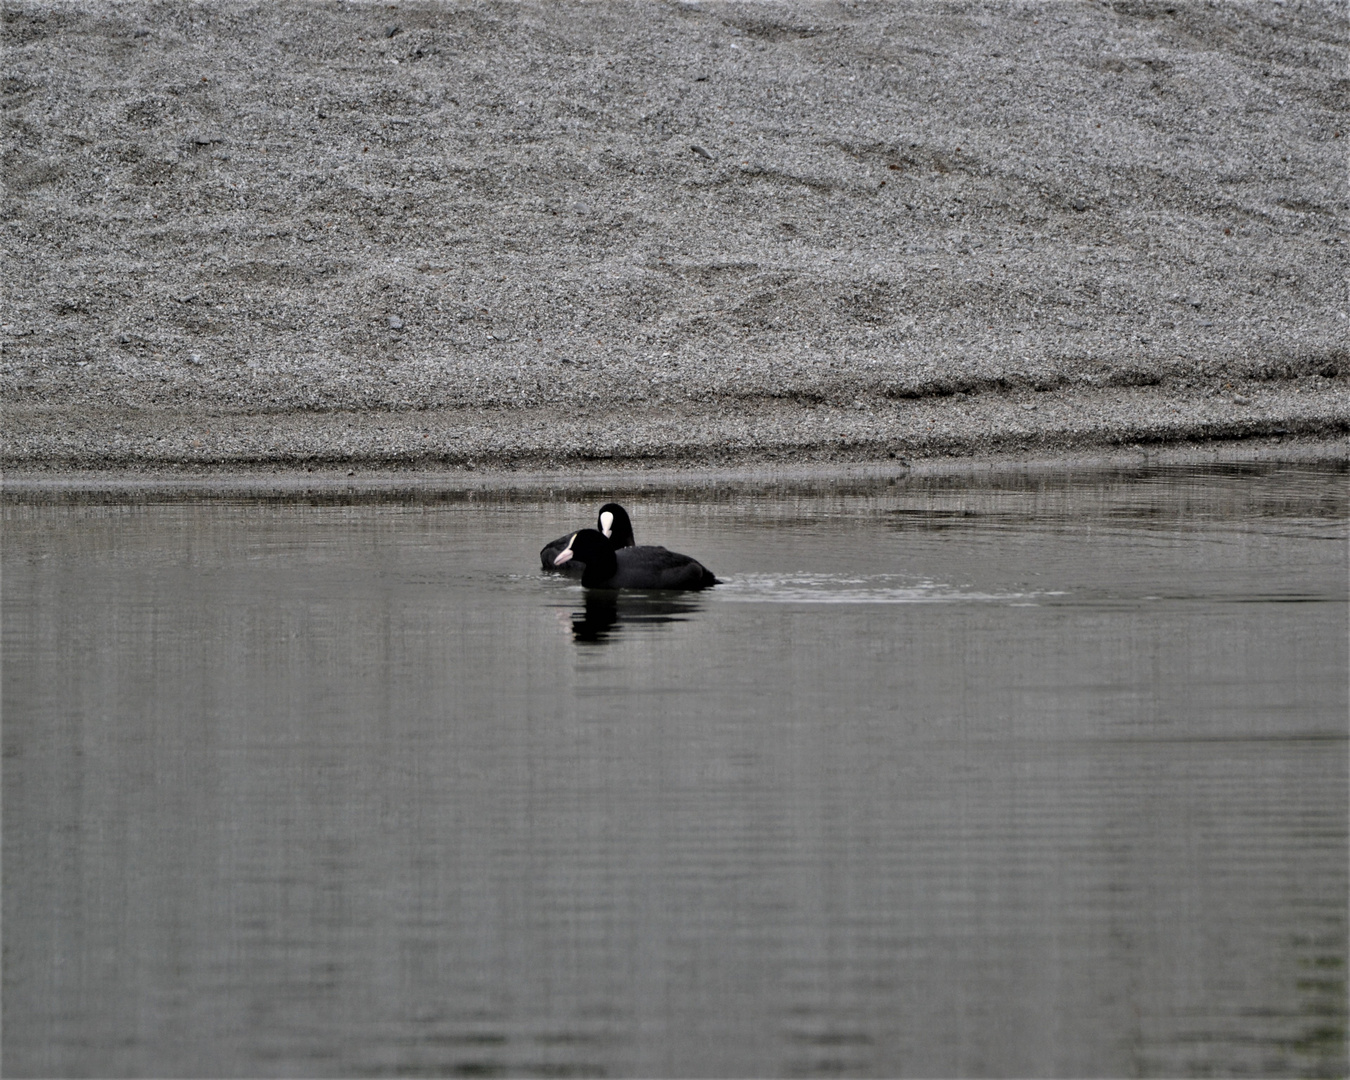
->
[0,0,1350,467]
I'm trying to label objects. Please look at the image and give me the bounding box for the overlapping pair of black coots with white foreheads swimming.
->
[539,502,717,590]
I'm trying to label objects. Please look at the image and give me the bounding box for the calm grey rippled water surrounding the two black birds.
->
[3,467,1350,1076]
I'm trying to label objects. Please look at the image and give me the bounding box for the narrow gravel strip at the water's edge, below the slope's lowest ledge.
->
[0,375,1350,473]
